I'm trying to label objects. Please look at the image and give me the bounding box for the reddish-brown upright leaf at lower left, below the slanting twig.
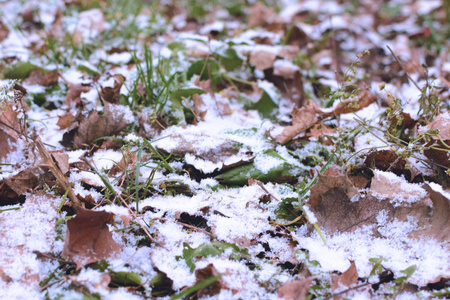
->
[62,208,121,269]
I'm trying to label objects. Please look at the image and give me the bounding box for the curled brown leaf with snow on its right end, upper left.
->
[74,102,132,148]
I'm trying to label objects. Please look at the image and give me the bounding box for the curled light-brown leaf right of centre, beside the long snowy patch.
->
[275,106,319,145]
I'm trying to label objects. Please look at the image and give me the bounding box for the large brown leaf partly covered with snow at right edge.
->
[307,171,450,242]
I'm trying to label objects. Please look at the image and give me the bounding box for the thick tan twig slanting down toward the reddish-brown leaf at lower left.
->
[31,131,84,211]
